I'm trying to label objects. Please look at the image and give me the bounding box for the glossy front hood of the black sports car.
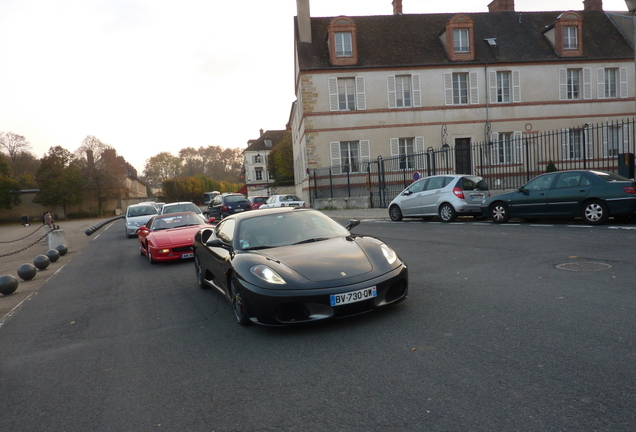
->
[259,237,373,282]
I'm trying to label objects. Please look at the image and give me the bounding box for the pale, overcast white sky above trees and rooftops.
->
[0,0,627,175]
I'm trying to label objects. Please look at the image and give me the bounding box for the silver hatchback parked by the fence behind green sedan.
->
[389,174,490,222]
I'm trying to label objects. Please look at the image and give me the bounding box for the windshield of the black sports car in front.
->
[238,211,349,250]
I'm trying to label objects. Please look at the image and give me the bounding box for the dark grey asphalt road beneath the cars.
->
[0,216,636,432]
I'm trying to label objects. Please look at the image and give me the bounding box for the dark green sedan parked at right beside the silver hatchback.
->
[481,170,636,225]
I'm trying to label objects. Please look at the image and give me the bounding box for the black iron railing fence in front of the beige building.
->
[309,119,636,207]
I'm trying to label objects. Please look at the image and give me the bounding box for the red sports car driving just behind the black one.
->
[137,212,214,264]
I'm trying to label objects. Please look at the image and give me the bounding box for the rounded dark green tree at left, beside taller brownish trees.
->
[33,146,86,218]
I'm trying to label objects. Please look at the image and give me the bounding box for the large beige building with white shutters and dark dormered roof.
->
[290,0,635,205]
